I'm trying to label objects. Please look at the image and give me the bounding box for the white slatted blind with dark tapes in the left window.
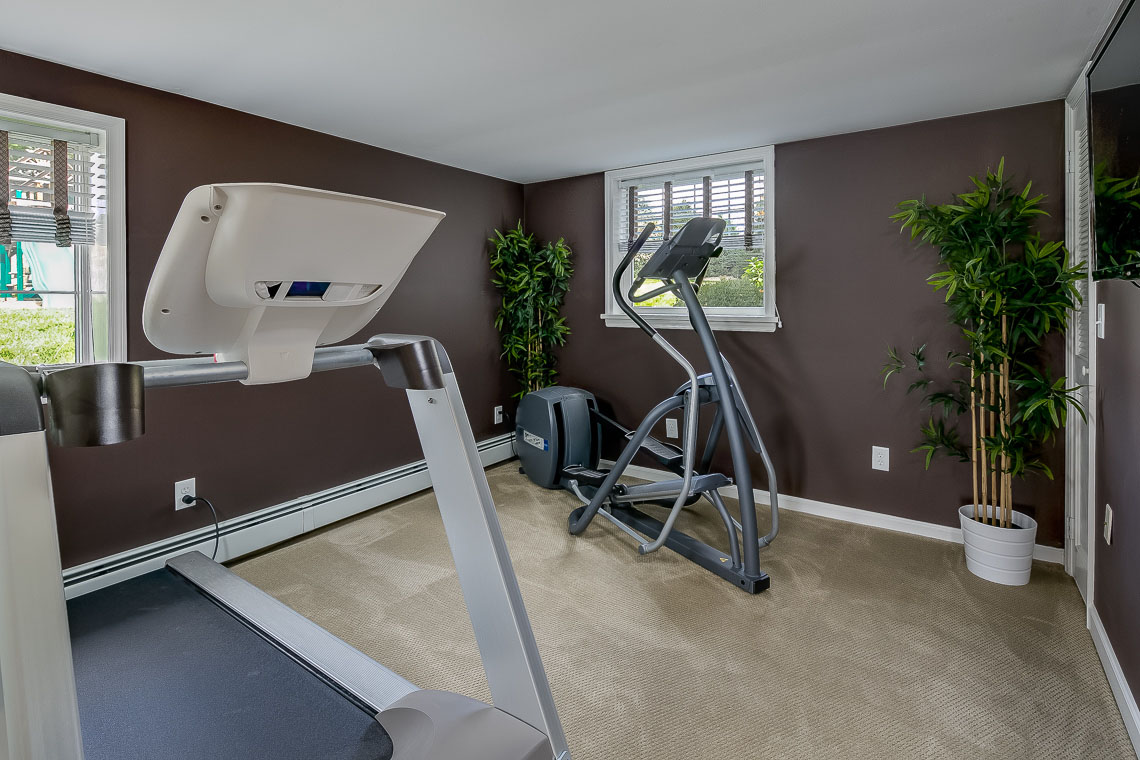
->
[0,127,107,245]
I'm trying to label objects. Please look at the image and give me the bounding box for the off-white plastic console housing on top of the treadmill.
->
[143,182,445,384]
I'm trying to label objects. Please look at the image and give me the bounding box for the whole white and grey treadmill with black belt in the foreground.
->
[0,183,570,760]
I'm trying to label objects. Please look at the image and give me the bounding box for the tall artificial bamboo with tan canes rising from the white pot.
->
[882,158,1085,528]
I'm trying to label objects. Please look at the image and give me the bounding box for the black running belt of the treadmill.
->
[67,569,392,760]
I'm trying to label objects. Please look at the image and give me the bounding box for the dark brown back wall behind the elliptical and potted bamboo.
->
[526,103,1064,546]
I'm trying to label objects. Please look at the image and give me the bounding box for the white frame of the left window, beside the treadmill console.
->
[0,92,127,361]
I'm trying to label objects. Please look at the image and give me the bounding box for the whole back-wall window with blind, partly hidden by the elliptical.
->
[602,146,779,332]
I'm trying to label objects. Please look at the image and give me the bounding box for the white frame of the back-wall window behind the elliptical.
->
[601,145,780,333]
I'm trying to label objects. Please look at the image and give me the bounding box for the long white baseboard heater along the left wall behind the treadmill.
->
[64,433,514,599]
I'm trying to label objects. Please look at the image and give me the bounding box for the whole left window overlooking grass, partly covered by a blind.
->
[0,95,127,365]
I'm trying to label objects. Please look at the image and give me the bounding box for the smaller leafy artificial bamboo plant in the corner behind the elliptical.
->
[490,222,573,398]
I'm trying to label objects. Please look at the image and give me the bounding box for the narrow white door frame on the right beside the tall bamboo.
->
[1065,64,1098,611]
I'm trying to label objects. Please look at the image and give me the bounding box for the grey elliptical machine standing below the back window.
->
[515,218,780,594]
